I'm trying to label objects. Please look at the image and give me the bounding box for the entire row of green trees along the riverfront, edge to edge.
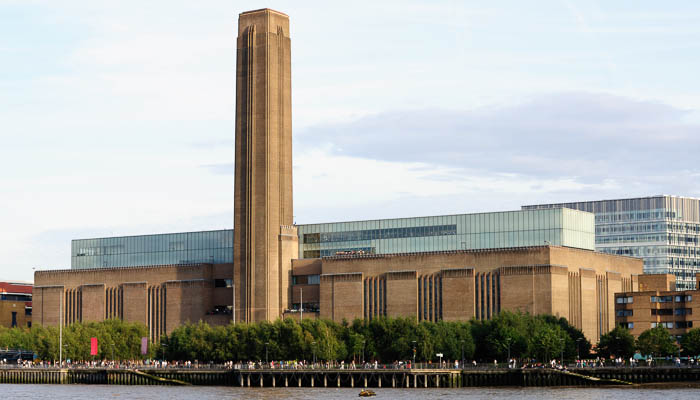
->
[0,311,700,363]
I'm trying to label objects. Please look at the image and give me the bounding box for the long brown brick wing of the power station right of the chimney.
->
[292,246,642,341]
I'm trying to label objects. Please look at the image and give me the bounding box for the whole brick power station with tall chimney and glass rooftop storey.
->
[34,9,642,341]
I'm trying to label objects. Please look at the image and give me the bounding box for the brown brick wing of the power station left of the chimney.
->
[34,264,233,341]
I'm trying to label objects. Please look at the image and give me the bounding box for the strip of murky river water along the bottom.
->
[0,384,700,400]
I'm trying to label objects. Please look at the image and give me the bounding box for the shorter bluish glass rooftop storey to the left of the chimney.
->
[71,229,233,269]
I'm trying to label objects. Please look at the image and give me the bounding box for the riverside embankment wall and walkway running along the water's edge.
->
[0,367,700,389]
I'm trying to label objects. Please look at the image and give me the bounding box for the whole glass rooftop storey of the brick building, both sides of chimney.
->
[71,208,595,269]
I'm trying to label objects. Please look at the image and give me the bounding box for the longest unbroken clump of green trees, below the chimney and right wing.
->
[162,311,591,363]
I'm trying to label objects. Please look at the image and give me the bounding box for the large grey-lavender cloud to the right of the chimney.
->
[297,93,700,194]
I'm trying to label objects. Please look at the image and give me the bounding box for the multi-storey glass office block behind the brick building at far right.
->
[523,196,700,290]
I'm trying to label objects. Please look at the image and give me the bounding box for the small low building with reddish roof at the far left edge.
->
[0,282,32,328]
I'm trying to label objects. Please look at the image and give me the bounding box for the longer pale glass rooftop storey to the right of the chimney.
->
[298,208,595,258]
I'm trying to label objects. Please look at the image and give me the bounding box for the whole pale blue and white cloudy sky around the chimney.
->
[0,0,700,281]
